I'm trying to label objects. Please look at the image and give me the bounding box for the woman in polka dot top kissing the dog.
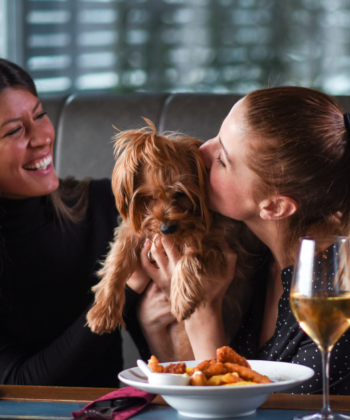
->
[142,87,350,394]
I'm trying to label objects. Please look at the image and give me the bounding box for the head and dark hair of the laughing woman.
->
[0,60,89,222]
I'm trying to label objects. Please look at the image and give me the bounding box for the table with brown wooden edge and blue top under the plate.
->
[0,385,350,420]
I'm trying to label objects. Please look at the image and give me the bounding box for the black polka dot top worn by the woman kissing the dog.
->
[231,254,350,395]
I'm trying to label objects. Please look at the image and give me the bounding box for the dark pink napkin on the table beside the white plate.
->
[72,386,157,420]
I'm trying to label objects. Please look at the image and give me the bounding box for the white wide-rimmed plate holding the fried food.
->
[118,360,315,418]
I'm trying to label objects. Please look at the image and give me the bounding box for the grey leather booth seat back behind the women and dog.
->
[42,93,350,368]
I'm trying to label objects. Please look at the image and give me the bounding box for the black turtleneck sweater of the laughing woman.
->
[0,180,148,387]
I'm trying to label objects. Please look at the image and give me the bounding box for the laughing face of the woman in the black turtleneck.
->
[0,88,59,199]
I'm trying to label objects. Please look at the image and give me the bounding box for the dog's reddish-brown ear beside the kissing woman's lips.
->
[187,138,211,230]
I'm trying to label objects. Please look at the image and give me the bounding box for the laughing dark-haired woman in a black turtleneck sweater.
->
[0,59,148,387]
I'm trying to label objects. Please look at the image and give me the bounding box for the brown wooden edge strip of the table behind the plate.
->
[0,385,350,411]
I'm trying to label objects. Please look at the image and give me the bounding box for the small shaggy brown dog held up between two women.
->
[87,119,253,334]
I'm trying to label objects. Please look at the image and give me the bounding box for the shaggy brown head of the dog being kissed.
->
[112,119,211,240]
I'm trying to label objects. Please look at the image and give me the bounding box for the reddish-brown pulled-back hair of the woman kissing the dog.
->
[244,87,350,251]
